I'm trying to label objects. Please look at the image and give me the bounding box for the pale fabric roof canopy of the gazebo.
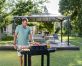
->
[14,14,68,22]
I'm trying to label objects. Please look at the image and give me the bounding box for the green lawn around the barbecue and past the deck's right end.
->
[0,37,82,66]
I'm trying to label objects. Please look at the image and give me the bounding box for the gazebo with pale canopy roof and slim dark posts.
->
[13,14,70,45]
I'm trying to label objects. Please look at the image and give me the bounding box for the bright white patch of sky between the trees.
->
[45,0,60,15]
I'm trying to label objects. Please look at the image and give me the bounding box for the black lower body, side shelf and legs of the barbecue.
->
[21,48,55,66]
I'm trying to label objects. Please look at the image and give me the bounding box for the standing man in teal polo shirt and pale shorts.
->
[14,18,32,66]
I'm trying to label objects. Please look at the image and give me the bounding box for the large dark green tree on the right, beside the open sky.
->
[59,0,82,35]
